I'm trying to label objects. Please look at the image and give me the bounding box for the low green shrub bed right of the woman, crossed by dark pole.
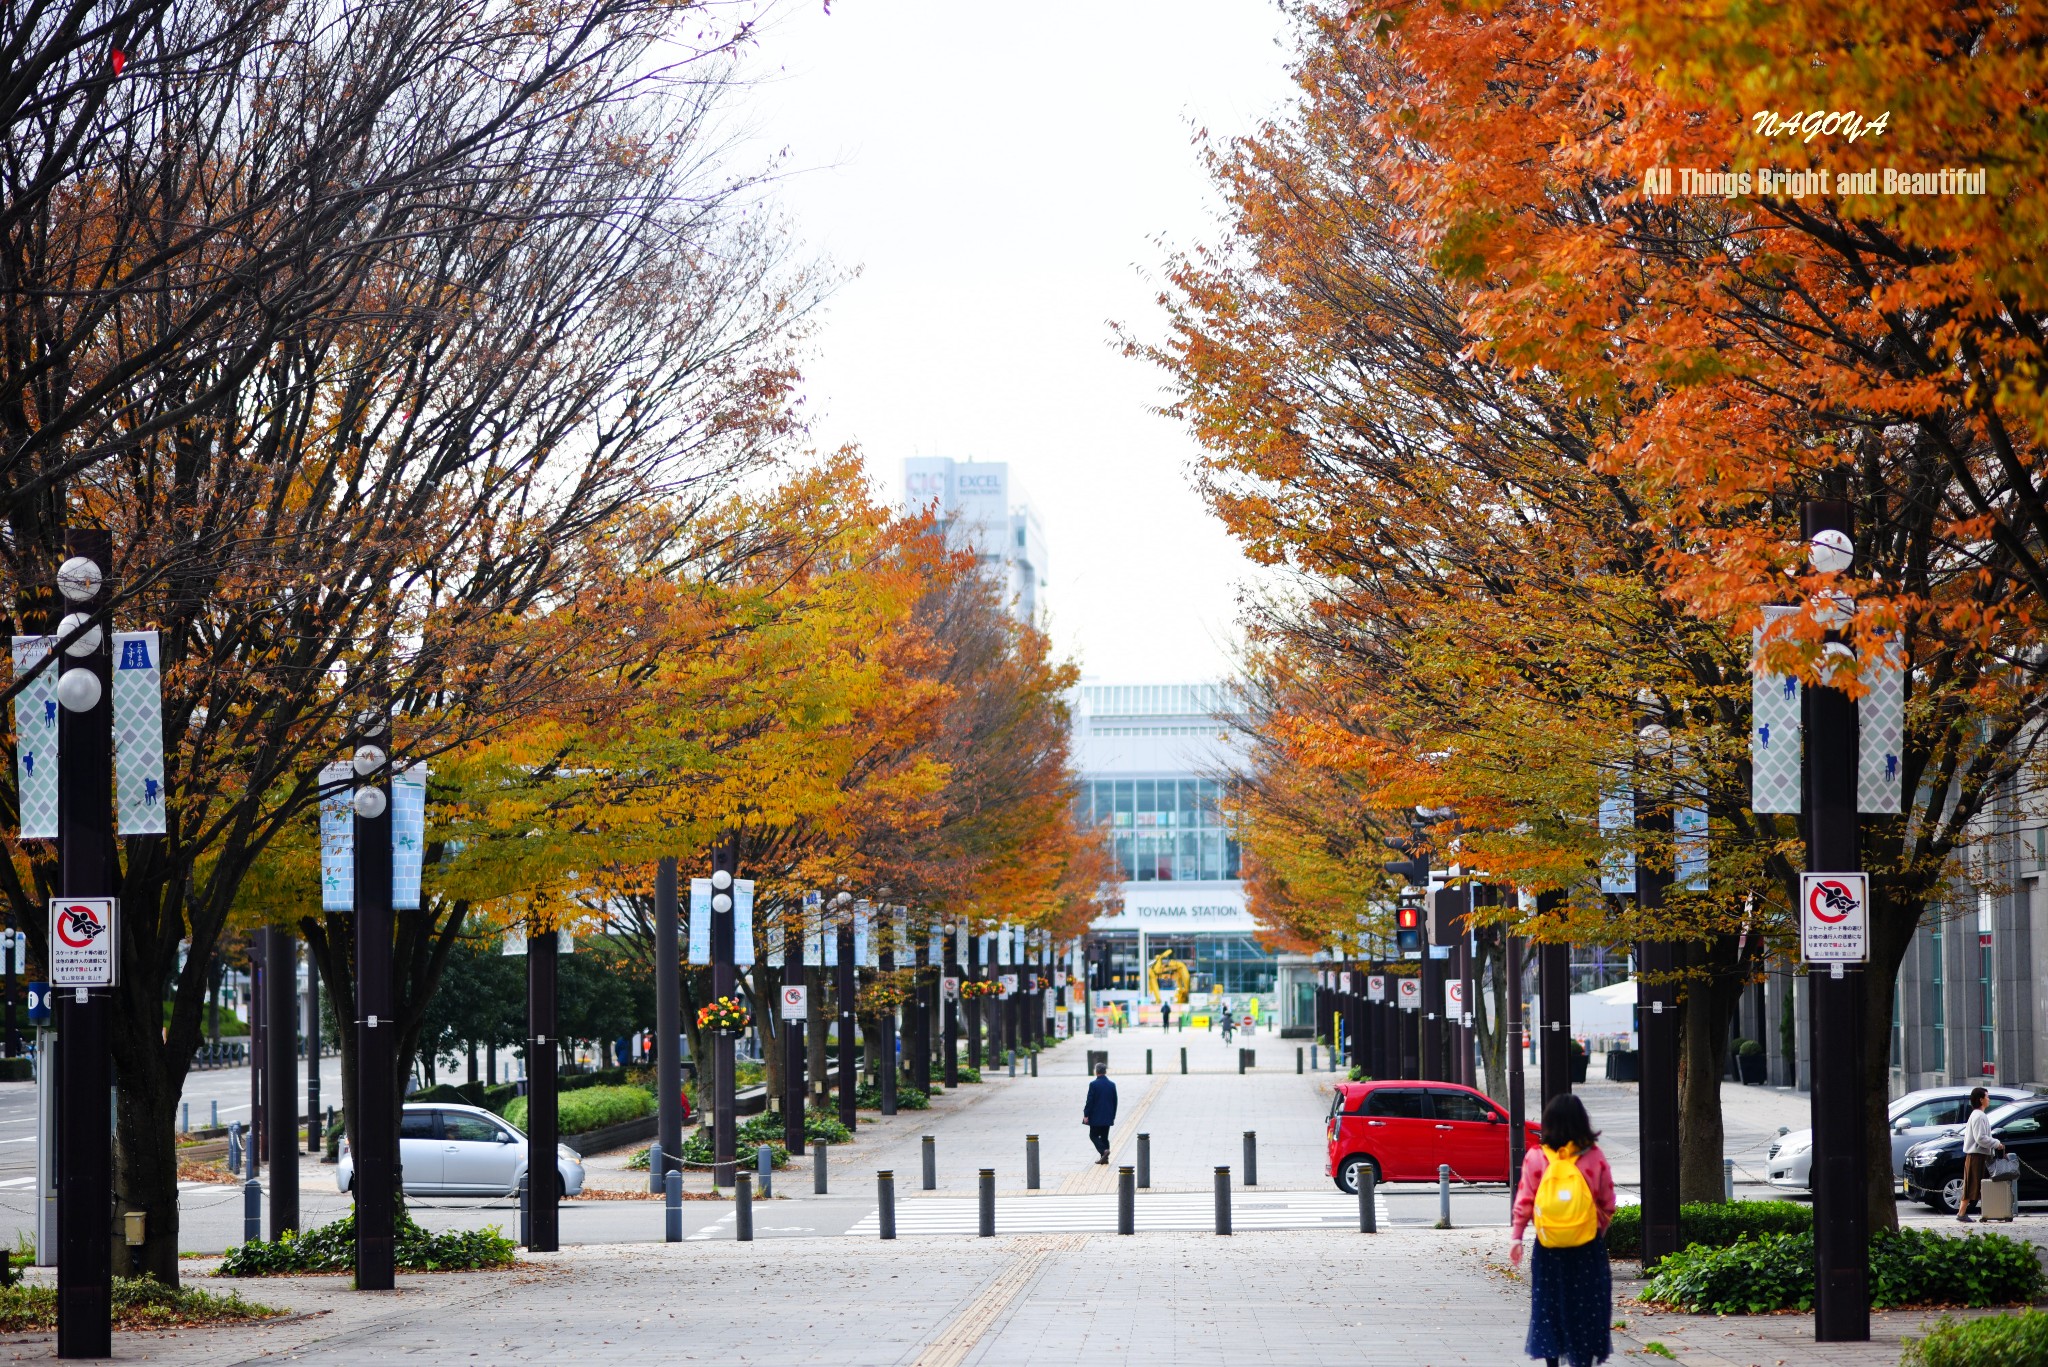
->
[1642,1230,2042,1314]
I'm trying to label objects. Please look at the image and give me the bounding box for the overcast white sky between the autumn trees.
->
[750,0,1288,682]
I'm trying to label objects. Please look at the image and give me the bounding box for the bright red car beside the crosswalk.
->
[1323,1080,1542,1193]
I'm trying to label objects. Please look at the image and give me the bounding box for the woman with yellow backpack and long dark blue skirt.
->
[1507,1092,1614,1367]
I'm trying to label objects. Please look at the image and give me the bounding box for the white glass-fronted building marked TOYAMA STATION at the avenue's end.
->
[1073,685,1315,1029]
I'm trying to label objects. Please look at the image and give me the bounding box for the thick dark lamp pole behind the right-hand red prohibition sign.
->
[1800,500,1870,1342]
